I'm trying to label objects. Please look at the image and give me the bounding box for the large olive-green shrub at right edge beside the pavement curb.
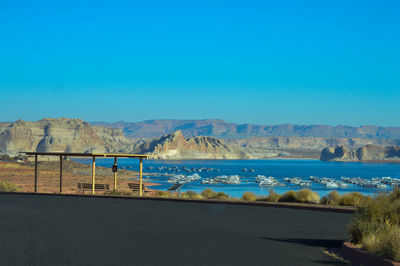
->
[349,189,400,260]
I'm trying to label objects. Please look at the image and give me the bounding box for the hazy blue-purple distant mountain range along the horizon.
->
[91,119,400,139]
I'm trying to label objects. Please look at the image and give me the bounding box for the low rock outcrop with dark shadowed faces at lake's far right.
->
[320,145,400,162]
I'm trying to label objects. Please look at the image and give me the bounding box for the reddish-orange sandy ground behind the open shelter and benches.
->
[0,160,156,194]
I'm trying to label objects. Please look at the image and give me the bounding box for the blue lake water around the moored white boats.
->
[76,159,400,197]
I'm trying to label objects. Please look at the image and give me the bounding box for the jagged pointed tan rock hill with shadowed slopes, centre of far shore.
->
[135,130,243,159]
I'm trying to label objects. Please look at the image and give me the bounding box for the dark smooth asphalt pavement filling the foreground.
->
[0,194,350,266]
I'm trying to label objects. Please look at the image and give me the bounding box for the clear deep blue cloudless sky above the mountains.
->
[0,0,400,126]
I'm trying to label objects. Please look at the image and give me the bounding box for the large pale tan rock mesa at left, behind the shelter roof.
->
[0,118,133,155]
